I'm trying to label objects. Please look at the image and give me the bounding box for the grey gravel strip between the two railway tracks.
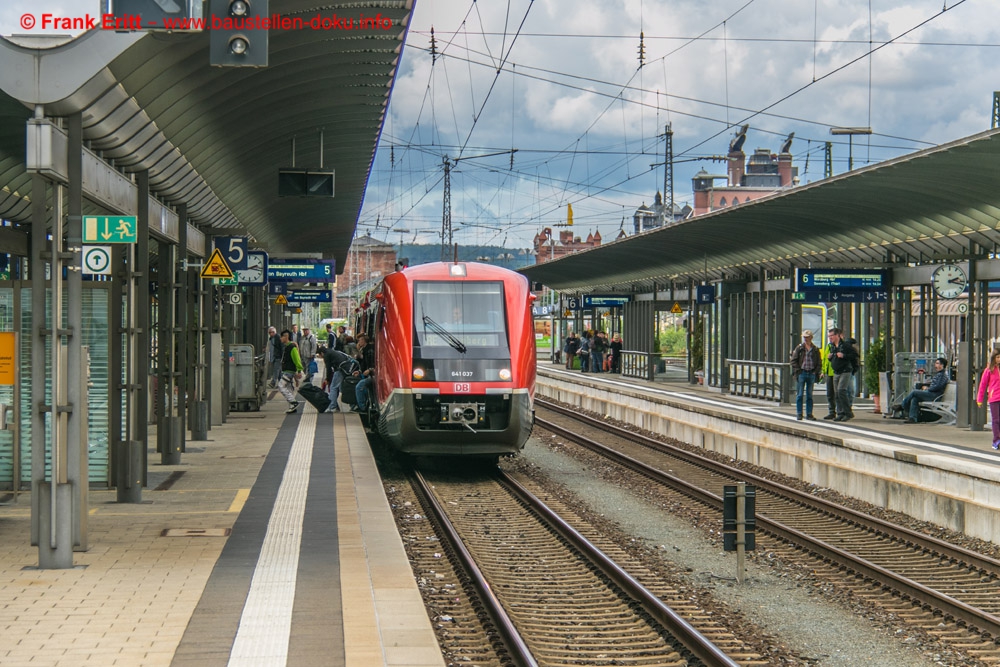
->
[509,438,954,667]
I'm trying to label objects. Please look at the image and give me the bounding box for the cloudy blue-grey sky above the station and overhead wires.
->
[0,0,1000,251]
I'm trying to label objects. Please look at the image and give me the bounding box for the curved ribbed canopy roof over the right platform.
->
[521,130,1000,292]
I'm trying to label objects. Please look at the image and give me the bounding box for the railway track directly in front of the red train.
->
[404,464,767,666]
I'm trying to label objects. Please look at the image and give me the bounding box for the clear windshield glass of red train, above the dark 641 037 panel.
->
[413,281,509,354]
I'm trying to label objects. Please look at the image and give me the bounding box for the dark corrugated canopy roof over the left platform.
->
[0,0,414,269]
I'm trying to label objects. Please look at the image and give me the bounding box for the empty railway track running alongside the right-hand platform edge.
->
[536,400,1000,662]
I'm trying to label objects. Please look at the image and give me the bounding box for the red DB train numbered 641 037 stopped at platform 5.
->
[355,262,535,457]
